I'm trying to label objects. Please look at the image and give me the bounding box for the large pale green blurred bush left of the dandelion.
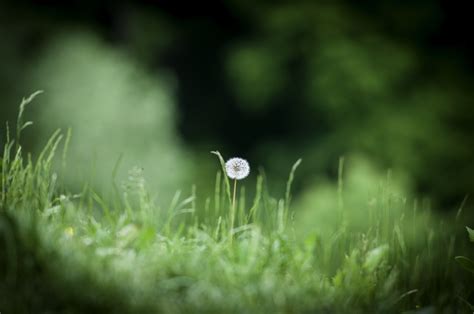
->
[25,33,190,202]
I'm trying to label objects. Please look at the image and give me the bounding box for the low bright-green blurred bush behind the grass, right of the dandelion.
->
[295,157,412,239]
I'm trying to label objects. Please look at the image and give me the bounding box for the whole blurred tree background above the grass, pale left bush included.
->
[0,0,474,209]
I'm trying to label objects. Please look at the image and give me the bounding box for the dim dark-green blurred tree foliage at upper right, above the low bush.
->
[225,2,474,206]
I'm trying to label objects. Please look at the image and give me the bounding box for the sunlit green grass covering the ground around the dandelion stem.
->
[0,94,473,313]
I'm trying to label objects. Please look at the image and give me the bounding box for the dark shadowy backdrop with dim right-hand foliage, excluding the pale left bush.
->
[0,0,474,209]
